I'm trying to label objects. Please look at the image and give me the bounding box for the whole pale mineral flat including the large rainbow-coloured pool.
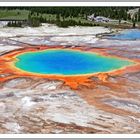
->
[0,24,140,134]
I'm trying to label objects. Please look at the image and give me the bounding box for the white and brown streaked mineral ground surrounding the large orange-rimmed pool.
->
[0,24,140,134]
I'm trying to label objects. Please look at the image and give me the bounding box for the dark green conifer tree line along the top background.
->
[2,7,140,27]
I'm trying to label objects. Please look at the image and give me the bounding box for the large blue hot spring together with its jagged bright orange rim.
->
[0,46,137,89]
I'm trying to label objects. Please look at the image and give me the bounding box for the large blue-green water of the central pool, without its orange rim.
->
[15,49,133,75]
